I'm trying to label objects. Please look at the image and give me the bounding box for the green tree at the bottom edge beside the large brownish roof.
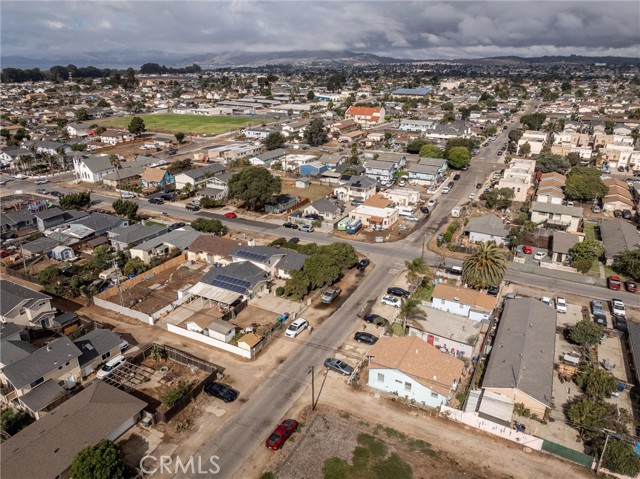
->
[70,439,125,479]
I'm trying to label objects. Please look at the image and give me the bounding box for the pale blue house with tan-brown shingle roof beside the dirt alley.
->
[367,336,464,408]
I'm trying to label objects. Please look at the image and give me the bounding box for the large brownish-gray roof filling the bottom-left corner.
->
[0,381,147,479]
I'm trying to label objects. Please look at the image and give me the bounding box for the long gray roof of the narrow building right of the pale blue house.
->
[482,298,556,406]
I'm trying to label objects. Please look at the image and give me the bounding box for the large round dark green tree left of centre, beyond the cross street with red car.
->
[228,166,282,211]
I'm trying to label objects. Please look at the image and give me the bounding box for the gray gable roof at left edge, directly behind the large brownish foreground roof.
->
[3,337,81,389]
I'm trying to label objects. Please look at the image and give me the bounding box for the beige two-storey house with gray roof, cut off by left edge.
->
[0,279,56,329]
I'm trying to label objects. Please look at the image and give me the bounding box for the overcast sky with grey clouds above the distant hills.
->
[0,0,640,65]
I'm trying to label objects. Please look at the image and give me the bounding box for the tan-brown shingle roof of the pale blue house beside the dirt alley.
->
[369,336,464,396]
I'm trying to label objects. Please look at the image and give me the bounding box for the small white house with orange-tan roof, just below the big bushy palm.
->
[431,283,498,321]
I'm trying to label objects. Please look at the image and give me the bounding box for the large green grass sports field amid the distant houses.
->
[91,114,273,136]
